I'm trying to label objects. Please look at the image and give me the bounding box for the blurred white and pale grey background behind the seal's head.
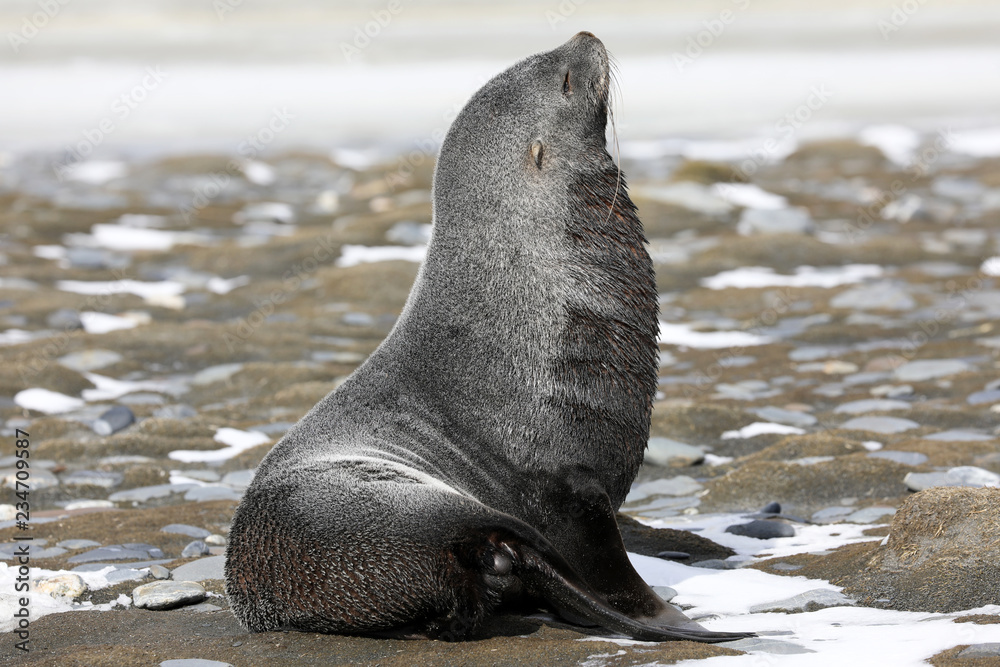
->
[0,0,1000,157]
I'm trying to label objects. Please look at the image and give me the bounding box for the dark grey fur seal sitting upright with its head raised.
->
[226,32,747,642]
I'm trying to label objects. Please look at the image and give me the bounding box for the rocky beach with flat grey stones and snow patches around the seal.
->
[0,121,1000,665]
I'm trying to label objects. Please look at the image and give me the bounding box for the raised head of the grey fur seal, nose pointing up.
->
[435,32,614,237]
